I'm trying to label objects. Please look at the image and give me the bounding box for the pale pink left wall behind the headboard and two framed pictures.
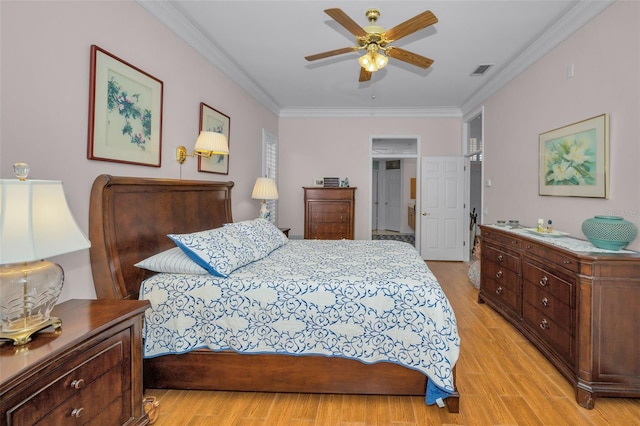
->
[0,1,278,301]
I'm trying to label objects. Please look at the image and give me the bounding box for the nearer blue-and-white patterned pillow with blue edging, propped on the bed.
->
[168,226,264,278]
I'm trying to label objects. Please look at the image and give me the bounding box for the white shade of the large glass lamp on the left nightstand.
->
[0,179,91,265]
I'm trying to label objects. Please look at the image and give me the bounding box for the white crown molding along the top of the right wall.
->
[460,0,615,114]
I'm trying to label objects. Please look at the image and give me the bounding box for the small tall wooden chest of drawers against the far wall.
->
[303,187,356,240]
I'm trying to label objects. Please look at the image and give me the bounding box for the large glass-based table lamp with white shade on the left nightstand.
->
[0,163,91,345]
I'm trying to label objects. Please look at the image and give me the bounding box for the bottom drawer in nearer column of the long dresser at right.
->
[522,302,573,365]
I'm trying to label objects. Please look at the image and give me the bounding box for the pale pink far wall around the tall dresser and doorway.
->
[278,118,462,239]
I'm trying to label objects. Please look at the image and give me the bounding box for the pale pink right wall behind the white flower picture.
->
[483,1,640,250]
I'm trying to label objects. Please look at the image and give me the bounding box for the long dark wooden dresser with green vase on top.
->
[478,226,640,409]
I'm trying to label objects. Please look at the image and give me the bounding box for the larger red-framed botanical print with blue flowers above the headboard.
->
[87,45,163,167]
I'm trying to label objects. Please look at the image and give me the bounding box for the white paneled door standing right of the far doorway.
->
[416,157,465,261]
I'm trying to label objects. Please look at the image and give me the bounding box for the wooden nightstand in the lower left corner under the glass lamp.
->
[0,300,149,426]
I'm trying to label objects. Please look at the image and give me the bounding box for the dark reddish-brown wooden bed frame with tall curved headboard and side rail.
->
[89,175,459,412]
